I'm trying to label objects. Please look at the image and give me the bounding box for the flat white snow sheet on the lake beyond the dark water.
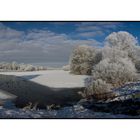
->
[0,70,88,88]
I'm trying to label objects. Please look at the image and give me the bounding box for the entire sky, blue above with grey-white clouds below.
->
[0,22,140,63]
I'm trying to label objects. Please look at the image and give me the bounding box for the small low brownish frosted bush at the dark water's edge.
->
[85,79,114,100]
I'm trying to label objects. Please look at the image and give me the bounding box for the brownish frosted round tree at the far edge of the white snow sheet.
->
[70,46,95,75]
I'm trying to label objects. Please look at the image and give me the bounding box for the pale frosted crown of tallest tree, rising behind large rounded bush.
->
[102,31,140,74]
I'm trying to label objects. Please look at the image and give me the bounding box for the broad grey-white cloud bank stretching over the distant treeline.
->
[0,24,101,63]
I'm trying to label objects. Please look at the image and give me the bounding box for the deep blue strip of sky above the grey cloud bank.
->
[3,22,140,41]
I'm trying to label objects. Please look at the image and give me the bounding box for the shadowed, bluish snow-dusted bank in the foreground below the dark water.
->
[0,105,137,118]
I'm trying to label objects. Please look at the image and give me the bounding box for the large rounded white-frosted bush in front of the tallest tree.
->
[93,58,136,87]
